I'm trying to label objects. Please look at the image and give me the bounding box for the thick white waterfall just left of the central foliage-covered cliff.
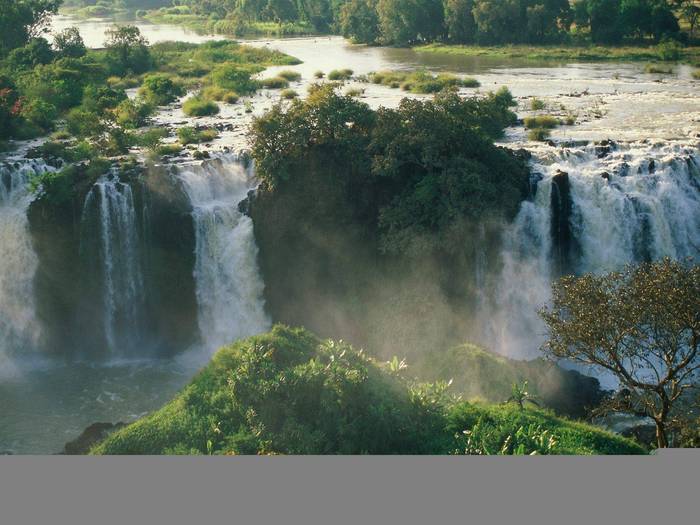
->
[178,156,270,350]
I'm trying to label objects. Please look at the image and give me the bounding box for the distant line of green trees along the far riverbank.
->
[66,0,700,45]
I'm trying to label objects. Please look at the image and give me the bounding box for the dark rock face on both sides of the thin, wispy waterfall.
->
[29,161,199,359]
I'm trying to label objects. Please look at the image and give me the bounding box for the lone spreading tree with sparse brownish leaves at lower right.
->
[540,259,700,447]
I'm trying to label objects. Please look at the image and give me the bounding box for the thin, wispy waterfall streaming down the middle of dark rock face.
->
[80,175,145,356]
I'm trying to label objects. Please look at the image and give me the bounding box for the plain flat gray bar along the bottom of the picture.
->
[0,450,700,525]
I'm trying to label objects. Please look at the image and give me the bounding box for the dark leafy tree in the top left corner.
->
[0,0,63,56]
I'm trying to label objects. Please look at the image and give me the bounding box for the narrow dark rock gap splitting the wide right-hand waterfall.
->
[551,171,577,276]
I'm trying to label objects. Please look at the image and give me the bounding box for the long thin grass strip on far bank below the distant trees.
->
[413,44,700,62]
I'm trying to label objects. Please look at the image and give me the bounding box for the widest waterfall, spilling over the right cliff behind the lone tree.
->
[482,143,700,357]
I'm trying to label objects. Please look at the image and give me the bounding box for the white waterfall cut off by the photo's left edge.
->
[0,160,53,368]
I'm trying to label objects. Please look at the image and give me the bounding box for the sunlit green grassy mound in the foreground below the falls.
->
[92,326,642,454]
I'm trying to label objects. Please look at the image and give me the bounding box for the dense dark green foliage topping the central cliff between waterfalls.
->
[252,84,526,252]
